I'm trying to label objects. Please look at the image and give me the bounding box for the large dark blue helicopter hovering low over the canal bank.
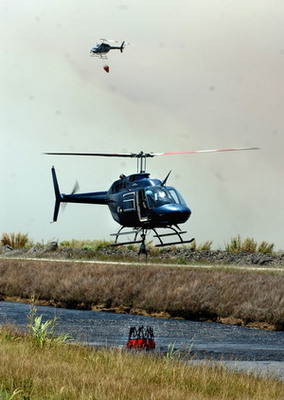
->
[44,147,257,255]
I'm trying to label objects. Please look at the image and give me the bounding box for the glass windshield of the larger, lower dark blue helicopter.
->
[145,186,185,208]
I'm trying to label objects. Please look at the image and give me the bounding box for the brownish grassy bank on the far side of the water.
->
[0,258,284,330]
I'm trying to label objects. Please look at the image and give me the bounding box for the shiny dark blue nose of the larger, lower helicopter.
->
[155,204,191,225]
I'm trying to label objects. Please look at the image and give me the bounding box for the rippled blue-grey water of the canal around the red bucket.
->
[0,301,284,379]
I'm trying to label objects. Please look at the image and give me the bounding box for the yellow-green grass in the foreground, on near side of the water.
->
[0,328,284,400]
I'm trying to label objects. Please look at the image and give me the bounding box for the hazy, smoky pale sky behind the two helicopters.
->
[0,0,284,249]
